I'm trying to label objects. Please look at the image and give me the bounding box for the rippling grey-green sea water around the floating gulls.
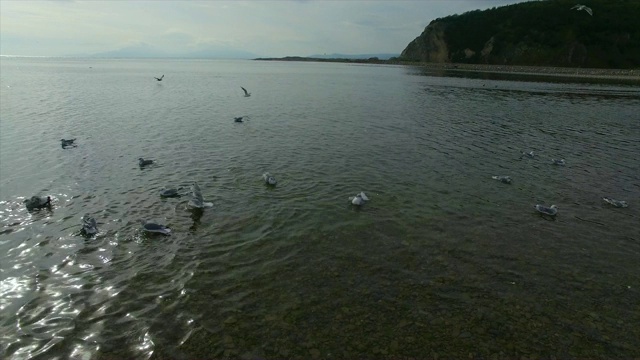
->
[0,58,640,359]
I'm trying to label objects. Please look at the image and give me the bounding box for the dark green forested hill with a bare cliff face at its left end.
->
[400,0,640,69]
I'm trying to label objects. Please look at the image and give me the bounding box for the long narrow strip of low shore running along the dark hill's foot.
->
[254,56,640,82]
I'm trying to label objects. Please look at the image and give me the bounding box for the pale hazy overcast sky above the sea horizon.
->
[0,0,523,58]
